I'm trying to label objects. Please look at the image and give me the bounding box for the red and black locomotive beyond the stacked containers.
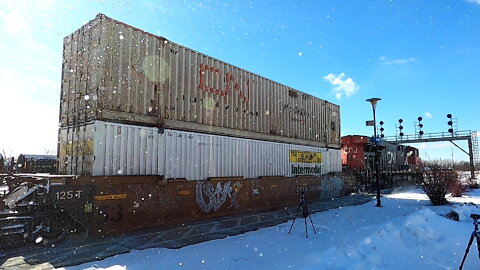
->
[341,135,422,189]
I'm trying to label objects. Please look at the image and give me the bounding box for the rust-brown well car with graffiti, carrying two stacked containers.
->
[0,14,354,246]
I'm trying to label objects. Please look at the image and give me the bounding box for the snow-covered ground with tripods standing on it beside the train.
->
[62,189,480,270]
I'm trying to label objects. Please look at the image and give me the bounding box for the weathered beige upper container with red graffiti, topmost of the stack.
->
[60,14,340,149]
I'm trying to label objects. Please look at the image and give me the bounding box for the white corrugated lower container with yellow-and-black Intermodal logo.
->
[60,121,341,180]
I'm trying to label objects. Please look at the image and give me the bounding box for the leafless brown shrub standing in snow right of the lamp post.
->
[423,161,464,205]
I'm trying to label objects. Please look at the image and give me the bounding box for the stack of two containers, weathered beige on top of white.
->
[59,14,341,177]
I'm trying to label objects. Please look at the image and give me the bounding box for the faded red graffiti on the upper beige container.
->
[198,64,250,102]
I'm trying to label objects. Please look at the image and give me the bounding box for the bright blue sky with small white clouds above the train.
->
[0,0,480,160]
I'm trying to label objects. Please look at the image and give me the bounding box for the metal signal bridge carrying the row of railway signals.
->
[384,130,480,178]
